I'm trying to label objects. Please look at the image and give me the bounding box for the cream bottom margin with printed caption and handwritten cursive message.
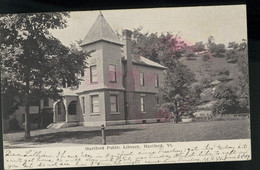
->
[4,139,251,169]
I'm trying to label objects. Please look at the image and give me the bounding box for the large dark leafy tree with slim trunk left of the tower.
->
[0,12,90,139]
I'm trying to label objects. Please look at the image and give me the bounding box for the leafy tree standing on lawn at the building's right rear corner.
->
[159,58,197,123]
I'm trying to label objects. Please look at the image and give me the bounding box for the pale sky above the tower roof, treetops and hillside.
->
[51,5,247,46]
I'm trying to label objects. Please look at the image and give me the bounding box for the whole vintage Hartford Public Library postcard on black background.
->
[0,5,252,169]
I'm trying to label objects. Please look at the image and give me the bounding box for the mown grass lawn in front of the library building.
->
[3,119,250,147]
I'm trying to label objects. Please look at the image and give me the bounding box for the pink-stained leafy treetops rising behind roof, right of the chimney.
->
[132,27,191,66]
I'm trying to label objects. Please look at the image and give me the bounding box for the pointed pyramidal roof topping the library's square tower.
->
[80,13,123,46]
